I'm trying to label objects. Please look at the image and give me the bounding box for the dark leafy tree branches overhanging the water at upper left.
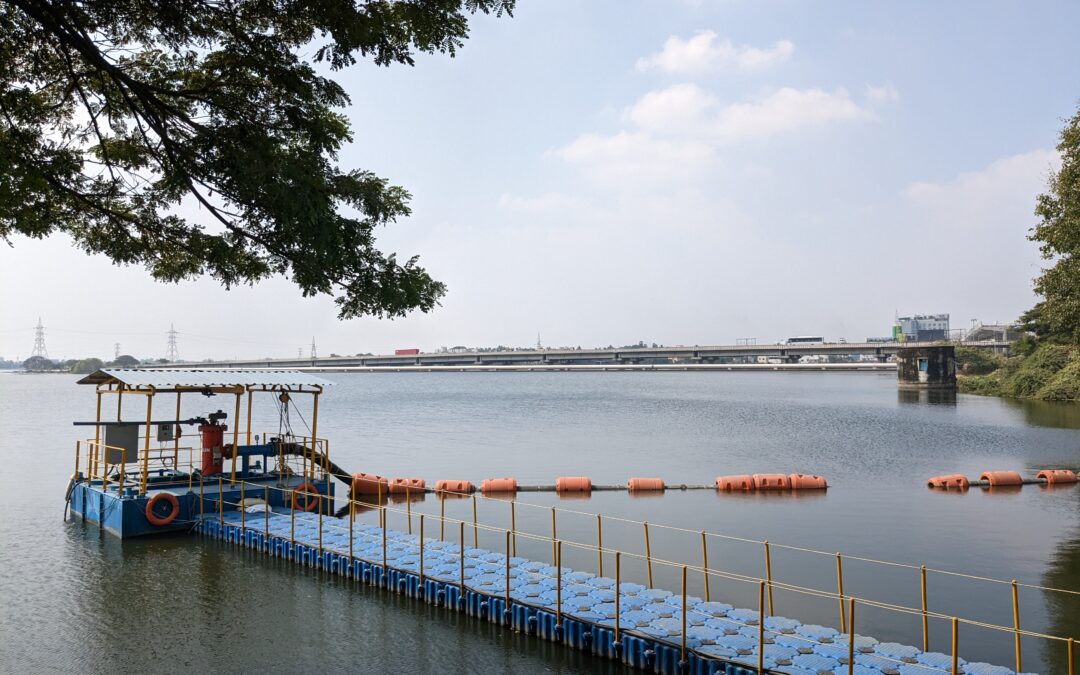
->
[0,0,515,318]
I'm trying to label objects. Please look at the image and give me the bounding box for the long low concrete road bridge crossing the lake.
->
[144,340,1009,369]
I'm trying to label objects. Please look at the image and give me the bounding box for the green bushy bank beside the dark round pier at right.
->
[956,340,1080,401]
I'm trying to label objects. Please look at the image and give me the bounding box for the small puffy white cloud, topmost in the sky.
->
[637,30,795,73]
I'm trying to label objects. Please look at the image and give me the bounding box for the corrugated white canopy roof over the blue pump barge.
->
[78,368,334,390]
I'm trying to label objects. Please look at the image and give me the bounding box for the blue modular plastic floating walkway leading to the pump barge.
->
[197,509,1028,675]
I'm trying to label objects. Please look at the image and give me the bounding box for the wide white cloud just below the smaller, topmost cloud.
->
[625,84,873,141]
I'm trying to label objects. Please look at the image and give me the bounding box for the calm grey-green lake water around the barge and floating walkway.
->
[0,373,1080,673]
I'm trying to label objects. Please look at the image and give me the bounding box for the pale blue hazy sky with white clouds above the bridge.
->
[0,0,1080,361]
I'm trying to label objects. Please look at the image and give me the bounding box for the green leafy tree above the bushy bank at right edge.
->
[1023,104,1080,343]
